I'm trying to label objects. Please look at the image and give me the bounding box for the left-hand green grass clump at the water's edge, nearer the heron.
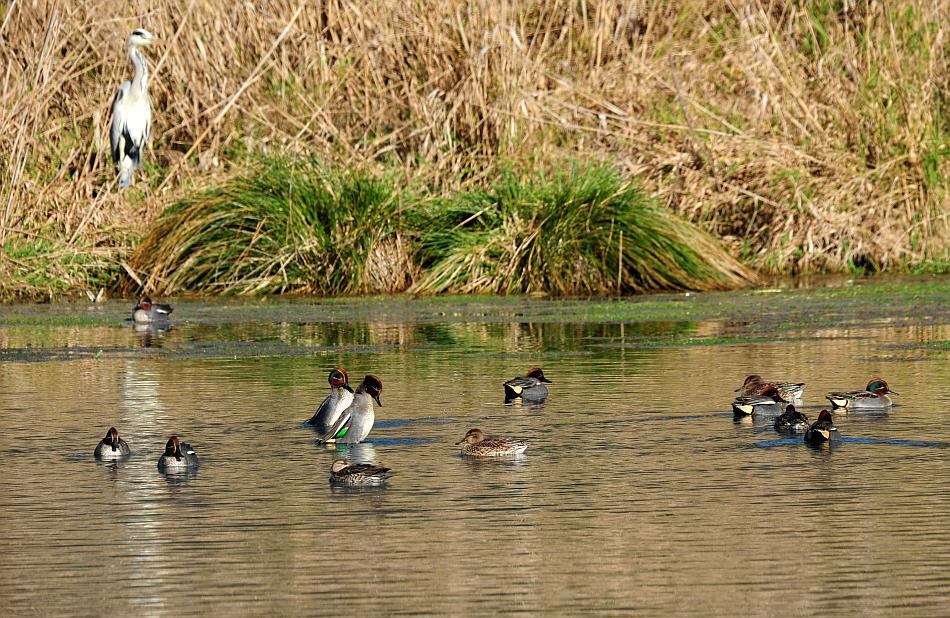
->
[131,158,410,294]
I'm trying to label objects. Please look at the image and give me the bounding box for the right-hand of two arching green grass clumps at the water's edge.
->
[413,166,754,295]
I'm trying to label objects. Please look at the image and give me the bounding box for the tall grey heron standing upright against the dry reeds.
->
[109,28,158,189]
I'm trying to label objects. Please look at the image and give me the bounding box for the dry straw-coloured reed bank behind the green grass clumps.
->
[0,0,950,298]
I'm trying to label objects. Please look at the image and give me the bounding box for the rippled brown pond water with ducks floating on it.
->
[0,279,950,616]
